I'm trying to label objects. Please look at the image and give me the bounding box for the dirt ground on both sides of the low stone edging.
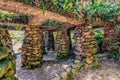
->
[16,55,120,80]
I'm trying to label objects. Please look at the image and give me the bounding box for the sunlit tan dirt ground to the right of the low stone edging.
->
[74,60,120,80]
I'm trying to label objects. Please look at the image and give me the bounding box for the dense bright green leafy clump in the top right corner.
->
[85,2,120,21]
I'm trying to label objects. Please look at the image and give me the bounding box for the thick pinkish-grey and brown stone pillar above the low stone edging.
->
[74,26,97,64]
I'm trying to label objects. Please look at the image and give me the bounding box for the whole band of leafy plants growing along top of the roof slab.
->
[22,0,120,21]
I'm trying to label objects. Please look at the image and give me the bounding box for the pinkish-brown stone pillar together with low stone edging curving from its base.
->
[52,25,99,80]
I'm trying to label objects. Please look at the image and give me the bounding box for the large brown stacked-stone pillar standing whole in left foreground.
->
[22,26,43,68]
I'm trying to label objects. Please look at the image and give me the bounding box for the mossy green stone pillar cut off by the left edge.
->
[0,29,17,80]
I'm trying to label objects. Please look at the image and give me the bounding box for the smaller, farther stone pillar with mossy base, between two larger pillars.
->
[55,31,69,59]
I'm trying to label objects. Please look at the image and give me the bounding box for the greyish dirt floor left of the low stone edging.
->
[16,55,73,80]
